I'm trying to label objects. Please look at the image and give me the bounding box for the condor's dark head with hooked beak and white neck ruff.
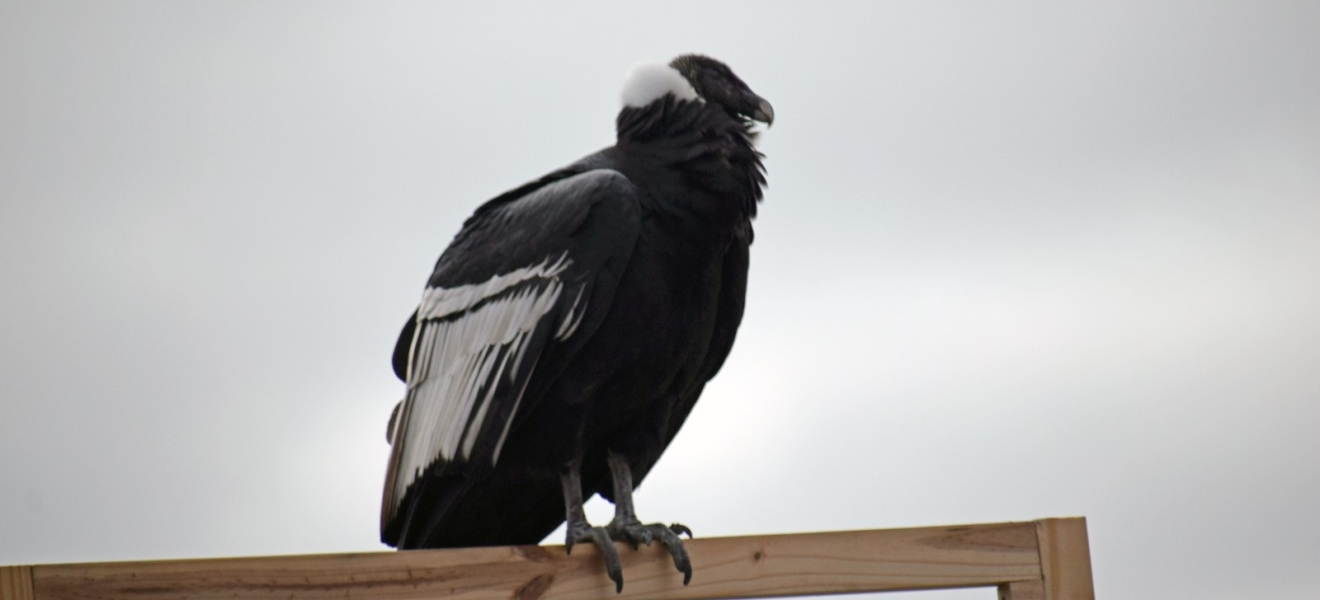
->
[623,54,775,125]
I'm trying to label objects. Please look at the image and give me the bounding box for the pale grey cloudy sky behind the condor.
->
[0,1,1320,600]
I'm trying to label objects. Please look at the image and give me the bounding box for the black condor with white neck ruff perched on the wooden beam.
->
[380,54,775,591]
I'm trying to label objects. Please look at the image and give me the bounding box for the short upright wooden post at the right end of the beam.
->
[1036,517,1096,600]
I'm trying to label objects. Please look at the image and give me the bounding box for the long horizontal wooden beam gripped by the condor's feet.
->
[32,522,1041,600]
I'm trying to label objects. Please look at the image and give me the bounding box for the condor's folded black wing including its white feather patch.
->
[381,169,639,542]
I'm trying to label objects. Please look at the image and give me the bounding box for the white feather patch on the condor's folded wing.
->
[389,252,586,512]
